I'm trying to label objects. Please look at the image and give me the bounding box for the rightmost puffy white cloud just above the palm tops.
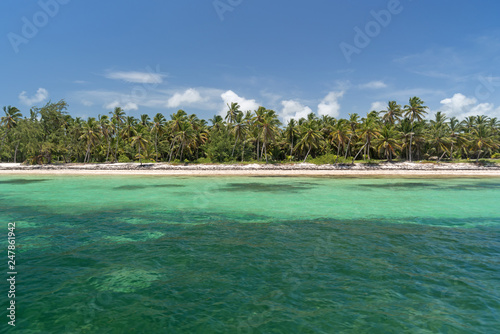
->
[441,93,500,119]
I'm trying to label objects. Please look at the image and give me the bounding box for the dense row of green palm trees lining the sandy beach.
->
[0,97,500,164]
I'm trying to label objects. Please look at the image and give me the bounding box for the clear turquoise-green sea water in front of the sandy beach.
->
[0,176,500,333]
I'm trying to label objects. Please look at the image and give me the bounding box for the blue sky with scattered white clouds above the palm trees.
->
[0,0,500,121]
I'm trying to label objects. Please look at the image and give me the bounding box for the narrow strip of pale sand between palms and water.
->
[0,162,500,177]
